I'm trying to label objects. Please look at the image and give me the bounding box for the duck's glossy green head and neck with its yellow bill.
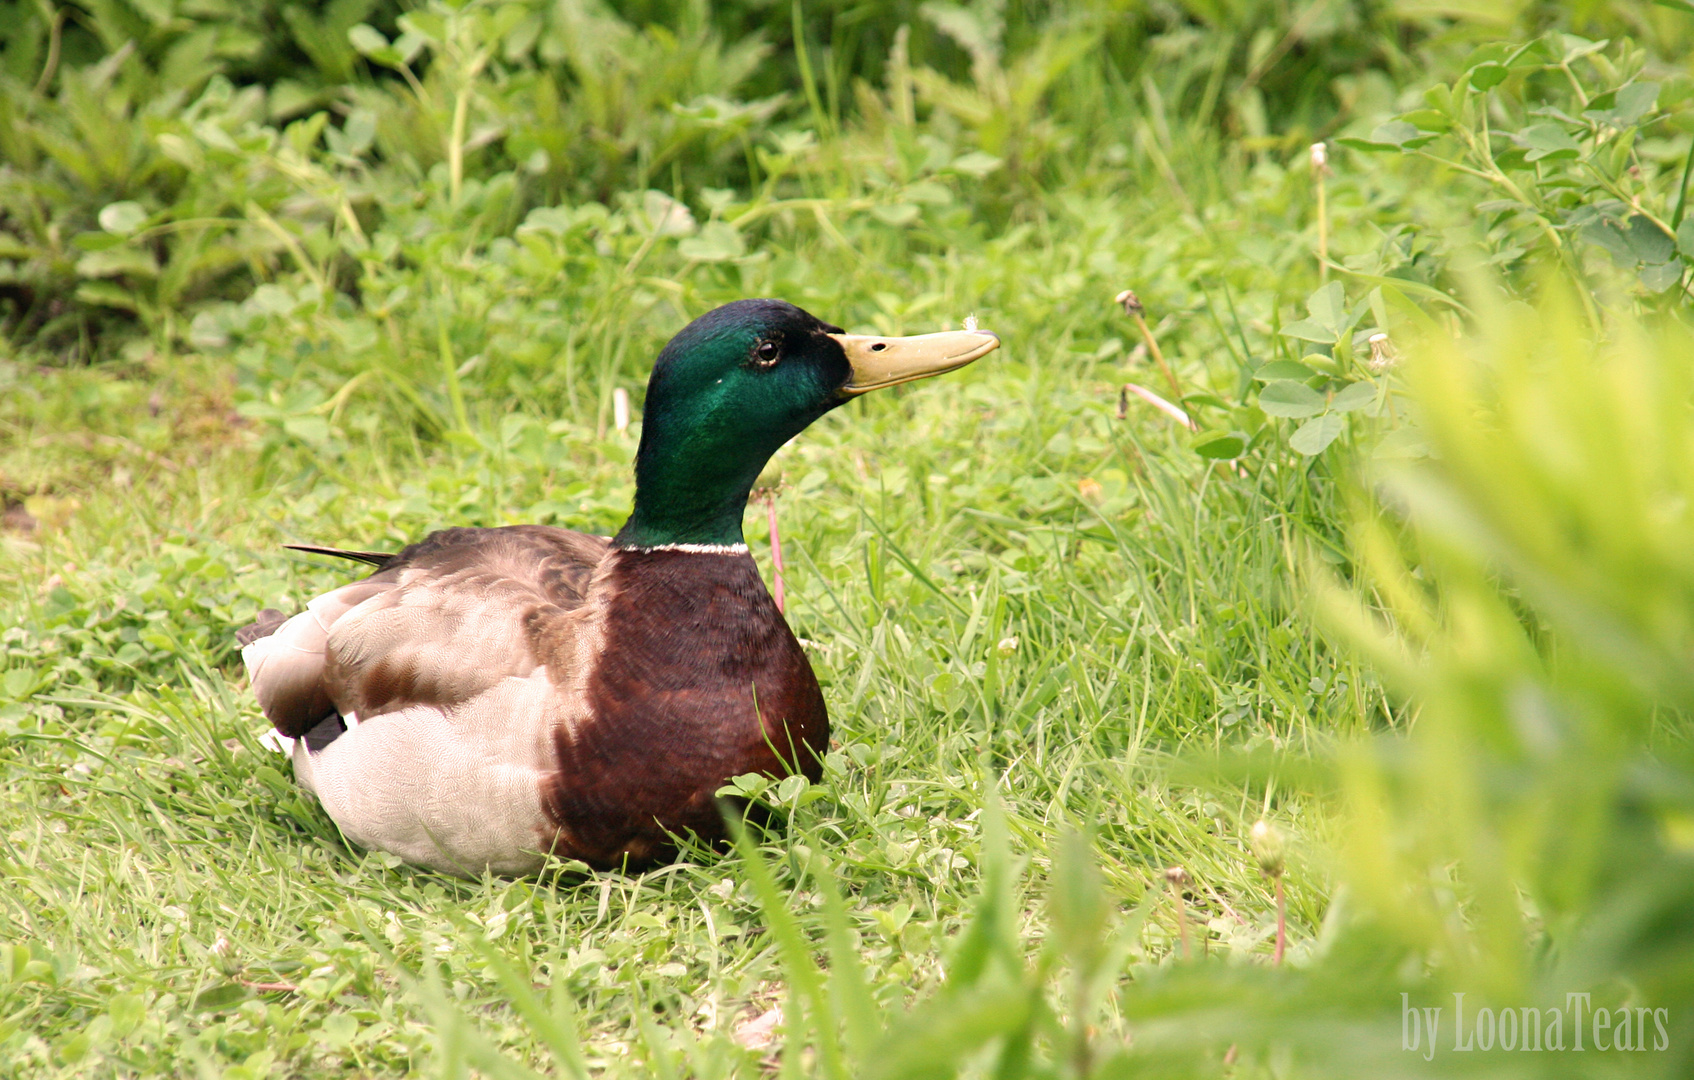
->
[615,300,999,547]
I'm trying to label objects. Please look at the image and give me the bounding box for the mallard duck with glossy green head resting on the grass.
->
[235,300,999,877]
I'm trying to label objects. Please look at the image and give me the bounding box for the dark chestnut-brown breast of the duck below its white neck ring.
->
[542,550,828,867]
